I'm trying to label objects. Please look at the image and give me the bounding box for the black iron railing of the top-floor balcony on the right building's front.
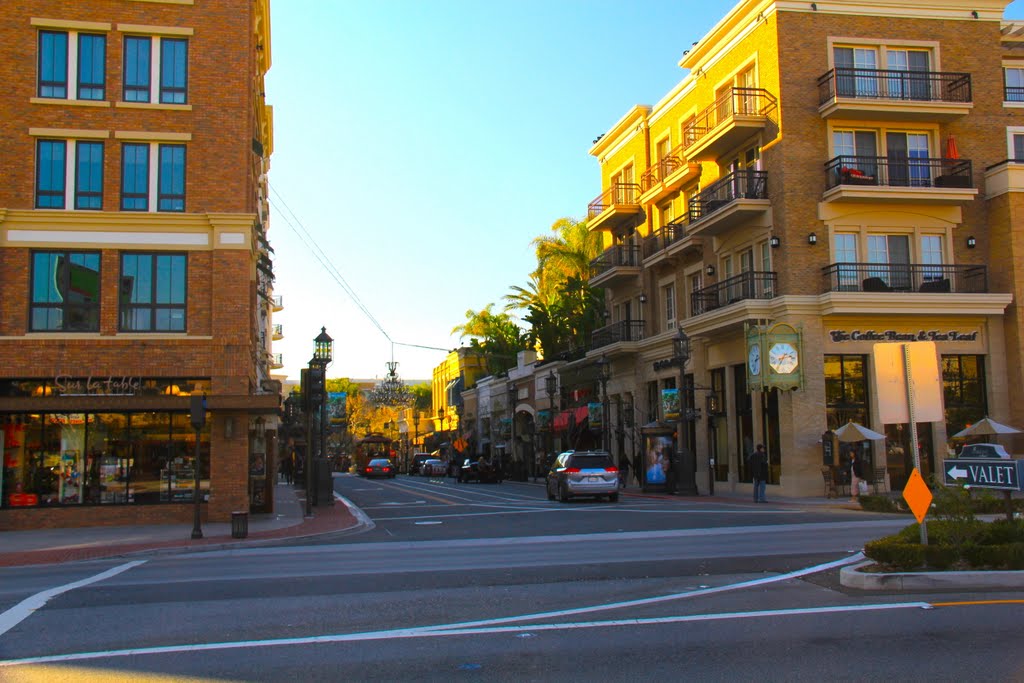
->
[818,67,972,104]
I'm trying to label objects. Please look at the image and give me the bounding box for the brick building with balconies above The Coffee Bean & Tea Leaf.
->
[577,0,1024,496]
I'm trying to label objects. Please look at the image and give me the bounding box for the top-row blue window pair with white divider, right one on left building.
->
[123,36,188,104]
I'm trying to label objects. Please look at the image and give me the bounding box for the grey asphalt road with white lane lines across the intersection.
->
[0,476,1024,682]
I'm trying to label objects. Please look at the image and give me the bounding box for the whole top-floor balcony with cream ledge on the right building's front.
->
[818,68,974,122]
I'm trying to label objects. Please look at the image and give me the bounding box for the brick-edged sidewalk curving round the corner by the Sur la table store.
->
[0,483,365,567]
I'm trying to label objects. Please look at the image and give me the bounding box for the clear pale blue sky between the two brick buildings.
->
[266,0,1024,380]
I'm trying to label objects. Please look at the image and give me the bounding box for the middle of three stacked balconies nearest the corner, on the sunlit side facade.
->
[689,170,771,236]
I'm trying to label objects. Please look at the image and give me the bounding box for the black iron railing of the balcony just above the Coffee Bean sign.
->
[821,263,988,294]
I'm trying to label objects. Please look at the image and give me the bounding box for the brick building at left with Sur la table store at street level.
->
[0,0,280,528]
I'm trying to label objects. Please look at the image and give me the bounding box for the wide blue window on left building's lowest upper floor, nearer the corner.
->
[120,254,187,332]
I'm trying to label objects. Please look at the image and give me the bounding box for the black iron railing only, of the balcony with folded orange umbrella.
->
[825,155,973,189]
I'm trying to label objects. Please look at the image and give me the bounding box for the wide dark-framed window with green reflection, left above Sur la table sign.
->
[29,252,99,332]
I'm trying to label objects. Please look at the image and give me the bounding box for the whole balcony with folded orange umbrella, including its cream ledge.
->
[822,155,978,204]
